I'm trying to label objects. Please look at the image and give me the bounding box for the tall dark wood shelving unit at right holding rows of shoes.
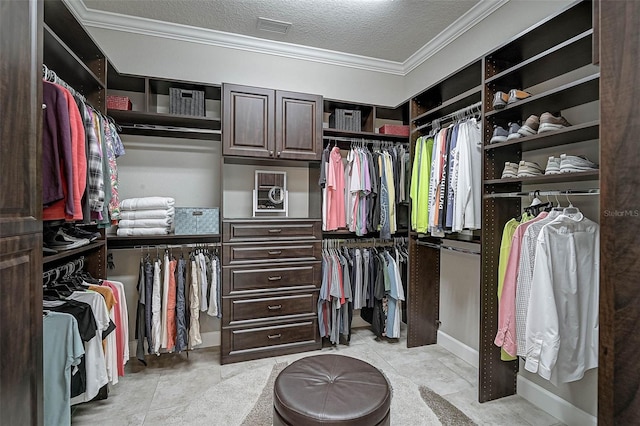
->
[478,1,600,402]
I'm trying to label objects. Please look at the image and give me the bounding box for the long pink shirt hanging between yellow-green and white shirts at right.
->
[494,212,548,356]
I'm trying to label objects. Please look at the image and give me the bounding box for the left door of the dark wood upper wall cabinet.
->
[222,84,275,157]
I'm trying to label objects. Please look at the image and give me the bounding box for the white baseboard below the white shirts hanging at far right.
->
[518,376,598,426]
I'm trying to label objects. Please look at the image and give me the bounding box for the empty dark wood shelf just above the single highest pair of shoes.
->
[485,29,593,92]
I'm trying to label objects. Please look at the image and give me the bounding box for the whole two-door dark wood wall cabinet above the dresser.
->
[222,84,322,160]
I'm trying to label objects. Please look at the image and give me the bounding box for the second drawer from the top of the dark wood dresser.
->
[222,241,322,265]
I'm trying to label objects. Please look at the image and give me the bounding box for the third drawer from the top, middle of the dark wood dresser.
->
[222,262,322,295]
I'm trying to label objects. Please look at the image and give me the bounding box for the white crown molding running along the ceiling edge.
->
[63,0,509,76]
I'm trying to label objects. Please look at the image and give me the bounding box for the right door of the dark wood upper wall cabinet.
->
[276,90,322,160]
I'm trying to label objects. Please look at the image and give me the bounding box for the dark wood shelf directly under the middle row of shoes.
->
[484,120,600,152]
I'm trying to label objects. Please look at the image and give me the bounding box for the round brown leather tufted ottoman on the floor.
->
[273,355,391,426]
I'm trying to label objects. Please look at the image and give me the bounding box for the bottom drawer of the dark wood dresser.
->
[222,318,320,355]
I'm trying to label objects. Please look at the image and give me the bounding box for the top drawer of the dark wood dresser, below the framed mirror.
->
[222,220,322,243]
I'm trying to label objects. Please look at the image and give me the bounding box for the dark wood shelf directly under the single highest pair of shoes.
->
[485,72,600,125]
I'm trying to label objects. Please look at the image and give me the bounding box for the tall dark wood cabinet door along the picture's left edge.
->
[0,0,43,425]
